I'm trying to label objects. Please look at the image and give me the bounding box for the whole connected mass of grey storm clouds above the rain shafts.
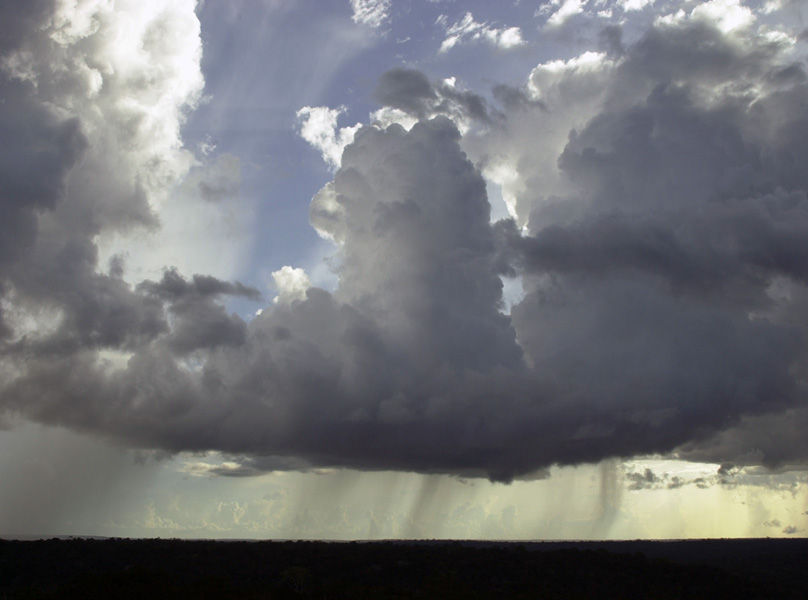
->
[0,4,808,480]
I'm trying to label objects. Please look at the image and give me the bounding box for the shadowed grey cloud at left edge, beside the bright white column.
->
[0,3,200,361]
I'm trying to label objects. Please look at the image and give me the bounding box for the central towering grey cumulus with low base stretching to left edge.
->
[3,120,533,477]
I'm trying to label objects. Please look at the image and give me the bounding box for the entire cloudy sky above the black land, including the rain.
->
[0,0,808,539]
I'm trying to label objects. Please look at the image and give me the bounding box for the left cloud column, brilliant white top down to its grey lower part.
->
[0,1,252,440]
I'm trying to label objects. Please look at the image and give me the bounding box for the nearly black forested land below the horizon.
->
[0,539,808,600]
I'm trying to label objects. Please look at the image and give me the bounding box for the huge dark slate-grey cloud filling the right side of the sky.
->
[502,18,808,472]
